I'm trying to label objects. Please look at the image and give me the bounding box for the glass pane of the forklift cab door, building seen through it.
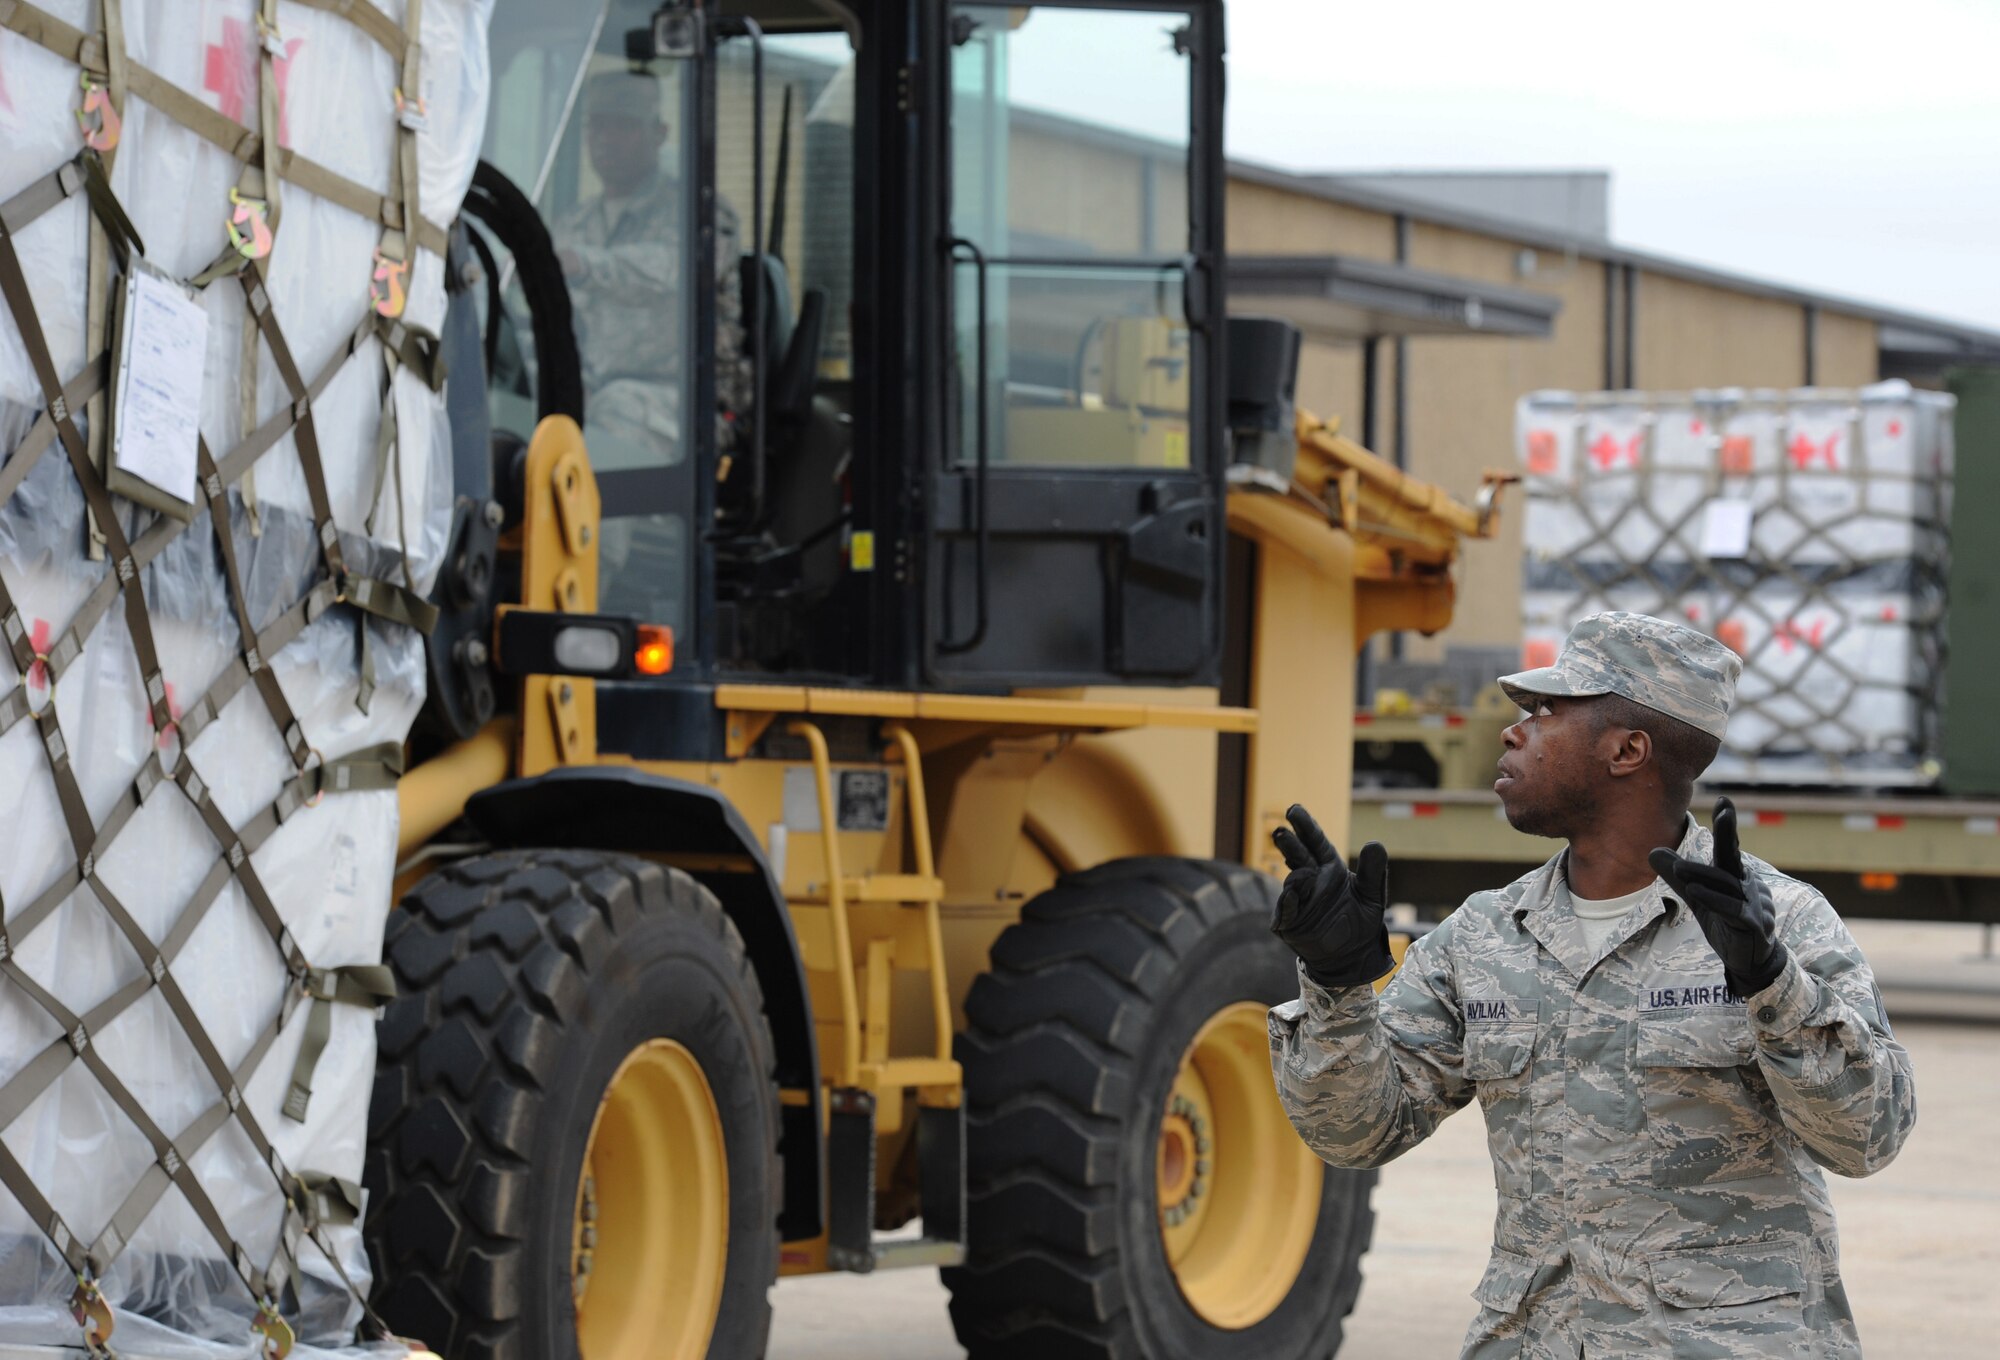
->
[952,6,1196,468]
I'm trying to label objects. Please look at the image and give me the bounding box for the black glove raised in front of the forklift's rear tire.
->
[1270,802,1396,988]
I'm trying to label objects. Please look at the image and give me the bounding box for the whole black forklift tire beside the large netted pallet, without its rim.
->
[364,850,784,1360]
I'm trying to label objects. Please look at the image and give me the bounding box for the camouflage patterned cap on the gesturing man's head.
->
[1500,610,1744,740]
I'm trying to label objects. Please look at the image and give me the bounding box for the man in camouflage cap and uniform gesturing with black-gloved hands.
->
[1270,612,1916,1360]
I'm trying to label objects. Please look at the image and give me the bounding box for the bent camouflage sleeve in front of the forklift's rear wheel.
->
[1270,922,1472,1166]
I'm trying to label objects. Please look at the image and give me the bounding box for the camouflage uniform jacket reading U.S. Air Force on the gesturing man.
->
[1270,824,1916,1360]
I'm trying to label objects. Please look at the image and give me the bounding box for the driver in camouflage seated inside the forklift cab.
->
[550,70,752,464]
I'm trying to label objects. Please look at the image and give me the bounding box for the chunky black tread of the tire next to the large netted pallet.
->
[364,850,784,1360]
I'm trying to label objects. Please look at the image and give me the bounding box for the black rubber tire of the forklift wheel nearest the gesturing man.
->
[944,858,1376,1360]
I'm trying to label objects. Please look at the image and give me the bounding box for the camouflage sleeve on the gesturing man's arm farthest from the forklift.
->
[1748,892,1916,1176]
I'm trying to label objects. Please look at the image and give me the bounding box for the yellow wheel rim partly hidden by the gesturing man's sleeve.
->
[1154,1002,1322,1330]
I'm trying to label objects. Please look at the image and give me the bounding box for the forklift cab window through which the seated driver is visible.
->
[482,0,704,656]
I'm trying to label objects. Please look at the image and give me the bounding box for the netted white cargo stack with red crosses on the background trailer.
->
[1516,382,1952,786]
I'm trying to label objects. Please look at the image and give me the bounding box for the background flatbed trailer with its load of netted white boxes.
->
[1348,374,2000,922]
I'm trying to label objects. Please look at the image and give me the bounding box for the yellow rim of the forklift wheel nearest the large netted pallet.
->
[570,1038,730,1360]
